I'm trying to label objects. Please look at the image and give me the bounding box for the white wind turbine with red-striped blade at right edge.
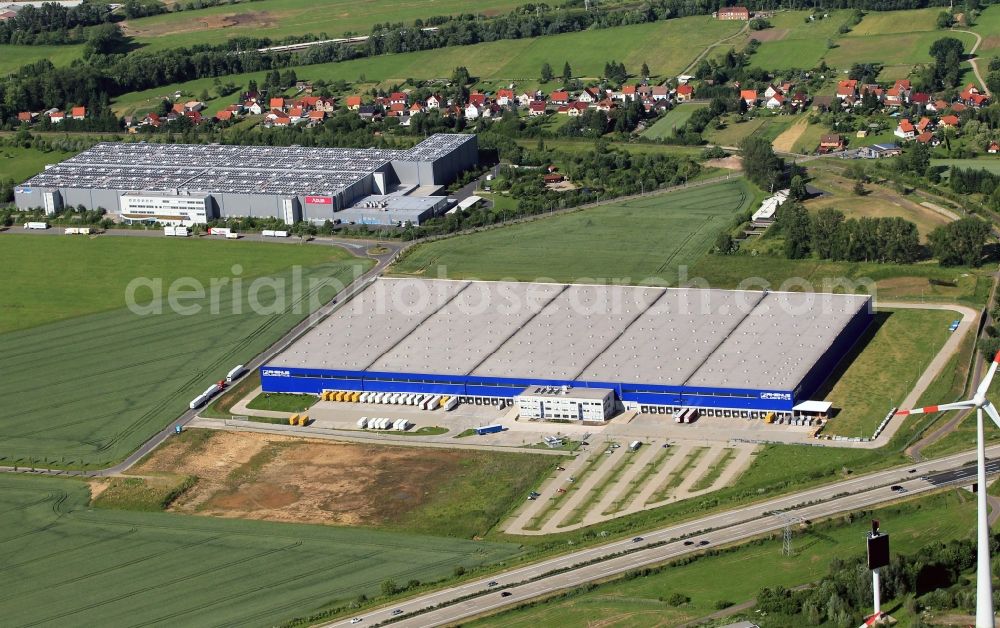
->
[896,352,1000,628]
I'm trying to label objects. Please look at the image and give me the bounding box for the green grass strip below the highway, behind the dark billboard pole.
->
[465,491,975,628]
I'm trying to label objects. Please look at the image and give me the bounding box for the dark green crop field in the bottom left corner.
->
[0,475,518,628]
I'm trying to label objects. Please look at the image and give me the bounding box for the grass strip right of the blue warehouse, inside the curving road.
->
[815,310,959,437]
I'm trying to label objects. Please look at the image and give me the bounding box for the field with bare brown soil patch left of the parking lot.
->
[122,430,555,539]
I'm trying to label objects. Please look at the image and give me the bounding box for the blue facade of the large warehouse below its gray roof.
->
[260,296,874,412]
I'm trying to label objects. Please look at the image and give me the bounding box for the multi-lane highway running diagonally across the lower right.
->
[326,446,1000,628]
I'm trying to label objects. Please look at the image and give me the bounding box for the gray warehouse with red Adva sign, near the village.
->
[14,133,479,225]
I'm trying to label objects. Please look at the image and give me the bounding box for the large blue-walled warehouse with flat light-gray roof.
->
[261,278,873,417]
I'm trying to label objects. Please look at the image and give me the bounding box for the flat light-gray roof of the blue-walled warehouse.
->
[271,278,870,390]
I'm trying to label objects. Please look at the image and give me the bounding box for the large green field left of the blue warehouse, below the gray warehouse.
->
[0,236,368,467]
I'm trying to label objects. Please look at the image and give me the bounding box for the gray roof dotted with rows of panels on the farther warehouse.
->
[23,133,475,196]
